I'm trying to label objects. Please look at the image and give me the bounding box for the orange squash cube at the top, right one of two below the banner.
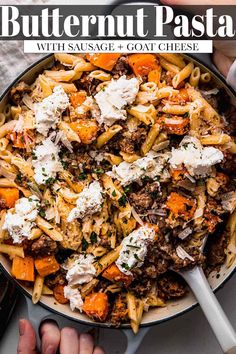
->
[128,54,160,76]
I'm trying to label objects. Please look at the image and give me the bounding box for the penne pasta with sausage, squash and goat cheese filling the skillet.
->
[0,53,236,333]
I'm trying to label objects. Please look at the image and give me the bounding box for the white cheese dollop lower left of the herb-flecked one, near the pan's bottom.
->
[63,254,96,286]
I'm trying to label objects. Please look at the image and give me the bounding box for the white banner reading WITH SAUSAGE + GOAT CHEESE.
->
[24,40,213,53]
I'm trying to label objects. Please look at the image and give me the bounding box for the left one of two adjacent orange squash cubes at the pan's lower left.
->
[11,256,35,281]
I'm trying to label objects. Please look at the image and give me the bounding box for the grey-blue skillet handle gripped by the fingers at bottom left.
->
[25,296,91,348]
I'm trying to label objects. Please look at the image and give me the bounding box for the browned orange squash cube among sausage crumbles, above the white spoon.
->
[166,192,196,220]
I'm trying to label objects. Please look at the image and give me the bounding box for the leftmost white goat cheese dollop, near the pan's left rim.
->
[3,195,39,243]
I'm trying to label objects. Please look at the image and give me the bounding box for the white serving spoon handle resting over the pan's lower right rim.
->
[179,267,236,354]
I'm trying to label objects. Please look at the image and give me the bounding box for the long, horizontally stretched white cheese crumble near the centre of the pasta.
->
[107,151,169,186]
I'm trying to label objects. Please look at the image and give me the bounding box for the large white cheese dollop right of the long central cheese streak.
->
[169,136,224,177]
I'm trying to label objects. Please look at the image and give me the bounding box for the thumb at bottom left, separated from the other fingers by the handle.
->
[17,319,36,354]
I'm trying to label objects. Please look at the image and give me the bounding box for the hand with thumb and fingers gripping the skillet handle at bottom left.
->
[17,319,105,354]
